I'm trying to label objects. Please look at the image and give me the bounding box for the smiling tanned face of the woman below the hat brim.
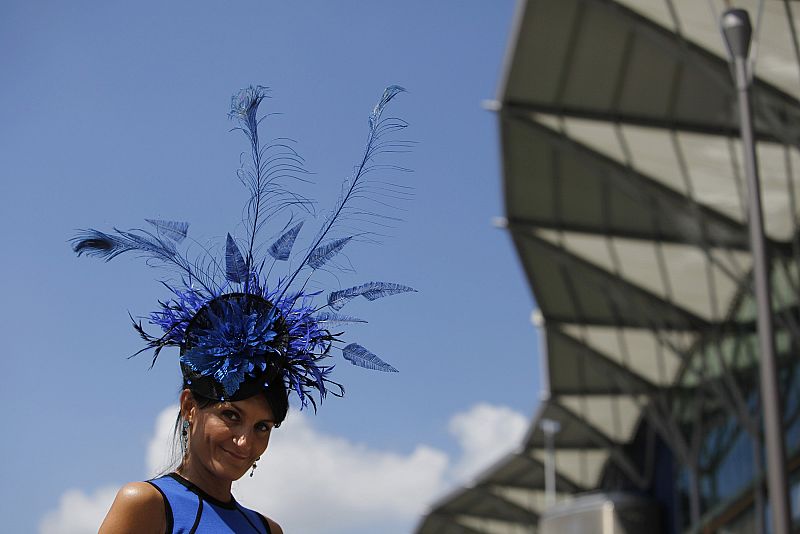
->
[181,390,275,481]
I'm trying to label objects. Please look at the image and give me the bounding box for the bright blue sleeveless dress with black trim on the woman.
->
[147,473,270,534]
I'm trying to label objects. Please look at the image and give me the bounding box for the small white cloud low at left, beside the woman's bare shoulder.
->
[39,486,117,534]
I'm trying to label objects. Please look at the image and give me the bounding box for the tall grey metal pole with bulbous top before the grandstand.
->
[721,9,791,534]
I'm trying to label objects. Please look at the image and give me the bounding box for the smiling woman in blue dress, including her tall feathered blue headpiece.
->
[72,86,414,534]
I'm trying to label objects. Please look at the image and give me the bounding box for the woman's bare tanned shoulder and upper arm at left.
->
[98,482,166,534]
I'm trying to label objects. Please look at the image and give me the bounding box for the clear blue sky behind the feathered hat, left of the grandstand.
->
[0,0,539,533]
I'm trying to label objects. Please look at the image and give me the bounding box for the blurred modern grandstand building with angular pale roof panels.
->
[417,0,800,534]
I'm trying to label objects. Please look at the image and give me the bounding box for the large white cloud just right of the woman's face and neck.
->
[236,413,448,532]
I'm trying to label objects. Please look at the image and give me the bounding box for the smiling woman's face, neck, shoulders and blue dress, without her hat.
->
[100,389,285,534]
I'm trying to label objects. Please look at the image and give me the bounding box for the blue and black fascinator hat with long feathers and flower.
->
[71,86,415,409]
